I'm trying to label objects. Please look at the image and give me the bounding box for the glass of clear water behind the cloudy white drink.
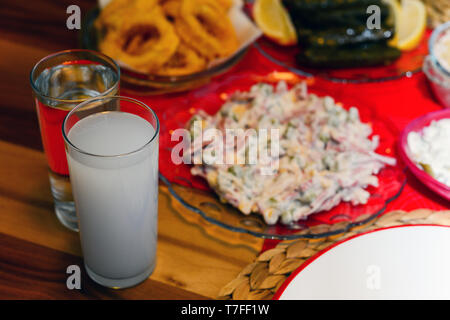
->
[30,49,120,231]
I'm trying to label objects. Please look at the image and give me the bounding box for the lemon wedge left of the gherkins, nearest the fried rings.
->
[253,0,297,45]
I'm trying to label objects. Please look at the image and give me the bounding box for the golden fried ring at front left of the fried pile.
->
[100,6,179,72]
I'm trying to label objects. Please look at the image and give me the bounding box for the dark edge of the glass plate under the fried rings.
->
[79,7,248,95]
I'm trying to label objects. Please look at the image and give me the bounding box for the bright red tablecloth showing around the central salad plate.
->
[129,48,450,250]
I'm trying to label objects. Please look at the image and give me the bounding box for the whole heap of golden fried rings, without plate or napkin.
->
[95,0,238,76]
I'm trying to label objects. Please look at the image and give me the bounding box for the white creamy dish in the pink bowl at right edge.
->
[408,119,450,187]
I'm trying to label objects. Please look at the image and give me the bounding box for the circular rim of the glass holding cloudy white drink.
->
[62,96,160,159]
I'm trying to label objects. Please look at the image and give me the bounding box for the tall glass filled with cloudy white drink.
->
[63,96,159,288]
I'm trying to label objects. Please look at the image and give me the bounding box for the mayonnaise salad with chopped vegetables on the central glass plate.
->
[189,82,396,224]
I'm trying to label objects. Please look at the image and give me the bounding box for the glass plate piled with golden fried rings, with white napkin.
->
[81,0,261,94]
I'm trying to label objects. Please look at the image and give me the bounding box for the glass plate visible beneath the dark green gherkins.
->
[246,0,431,83]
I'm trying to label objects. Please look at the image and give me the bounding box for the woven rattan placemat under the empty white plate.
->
[218,209,450,300]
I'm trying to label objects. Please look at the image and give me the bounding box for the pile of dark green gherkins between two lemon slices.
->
[282,0,401,68]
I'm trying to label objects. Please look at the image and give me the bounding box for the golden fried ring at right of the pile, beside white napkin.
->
[175,0,238,59]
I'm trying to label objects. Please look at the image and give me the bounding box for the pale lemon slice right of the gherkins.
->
[396,0,427,51]
